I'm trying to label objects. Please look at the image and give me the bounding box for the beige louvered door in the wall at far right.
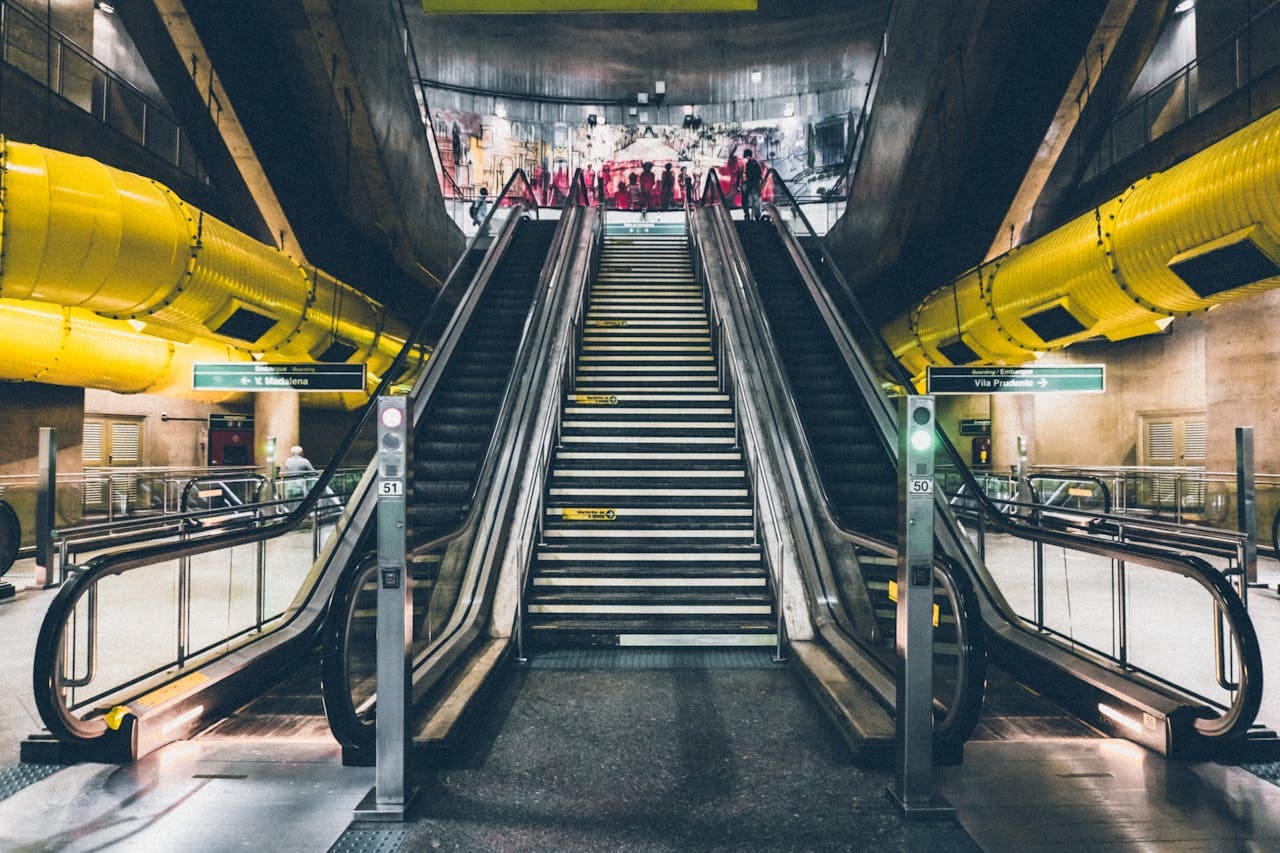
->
[1138,411,1206,515]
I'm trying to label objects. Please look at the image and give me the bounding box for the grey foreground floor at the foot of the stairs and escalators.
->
[0,550,1280,852]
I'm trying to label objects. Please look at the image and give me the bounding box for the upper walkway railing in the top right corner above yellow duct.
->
[1083,1,1280,181]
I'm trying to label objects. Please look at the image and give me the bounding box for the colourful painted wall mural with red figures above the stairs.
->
[433,110,849,209]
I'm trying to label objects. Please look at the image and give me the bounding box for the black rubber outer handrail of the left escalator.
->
[32,169,536,740]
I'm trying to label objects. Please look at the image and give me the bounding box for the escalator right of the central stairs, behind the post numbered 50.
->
[708,173,1266,756]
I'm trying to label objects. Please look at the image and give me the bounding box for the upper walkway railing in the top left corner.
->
[0,0,209,183]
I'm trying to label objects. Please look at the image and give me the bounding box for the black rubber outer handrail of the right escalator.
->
[747,169,1262,738]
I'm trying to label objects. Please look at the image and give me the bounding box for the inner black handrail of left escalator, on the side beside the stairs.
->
[321,170,599,748]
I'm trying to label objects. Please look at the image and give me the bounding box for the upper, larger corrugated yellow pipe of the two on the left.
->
[0,141,419,379]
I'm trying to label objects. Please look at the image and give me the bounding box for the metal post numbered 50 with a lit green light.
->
[887,396,955,820]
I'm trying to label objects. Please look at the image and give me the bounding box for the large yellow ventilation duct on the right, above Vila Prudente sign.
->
[882,103,1280,377]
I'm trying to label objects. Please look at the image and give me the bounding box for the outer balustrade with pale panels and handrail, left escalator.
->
[33,166,537,756]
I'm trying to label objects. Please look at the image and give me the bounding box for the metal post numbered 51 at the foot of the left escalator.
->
[356,397,413,821]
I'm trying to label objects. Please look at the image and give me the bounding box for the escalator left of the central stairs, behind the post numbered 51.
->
[23,173,556,761]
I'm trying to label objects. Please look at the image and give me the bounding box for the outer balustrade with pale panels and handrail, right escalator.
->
[747,170,1262,738]
